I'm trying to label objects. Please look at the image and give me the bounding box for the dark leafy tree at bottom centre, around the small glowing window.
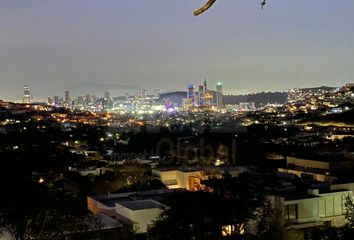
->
[149,173,264,240]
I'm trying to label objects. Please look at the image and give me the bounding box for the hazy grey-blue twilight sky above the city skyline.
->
[0,0,354,100]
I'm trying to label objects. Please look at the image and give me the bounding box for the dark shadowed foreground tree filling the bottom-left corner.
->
[0,181,100,240]
